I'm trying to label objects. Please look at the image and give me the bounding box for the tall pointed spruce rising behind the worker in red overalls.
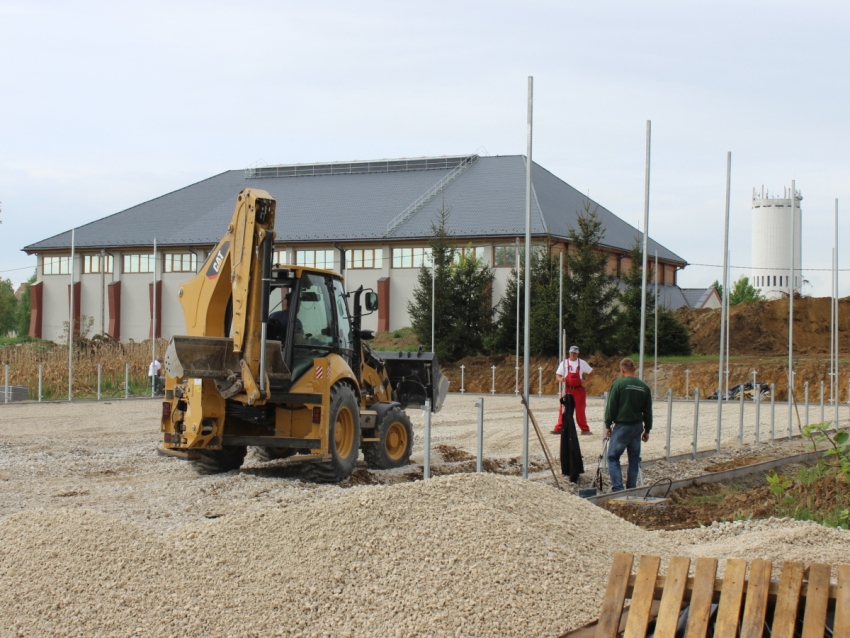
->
[555,201,619,354]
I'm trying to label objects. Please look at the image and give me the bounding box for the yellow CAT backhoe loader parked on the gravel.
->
[161,189,448,482]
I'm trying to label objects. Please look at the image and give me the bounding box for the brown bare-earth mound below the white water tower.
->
[675,297,850,355]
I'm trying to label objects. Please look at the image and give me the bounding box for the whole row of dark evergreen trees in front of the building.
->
[408,204,691,361]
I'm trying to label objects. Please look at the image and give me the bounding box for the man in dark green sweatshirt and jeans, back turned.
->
[605,358,652,492]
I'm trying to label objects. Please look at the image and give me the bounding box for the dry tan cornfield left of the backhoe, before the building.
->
[0,338,168,400]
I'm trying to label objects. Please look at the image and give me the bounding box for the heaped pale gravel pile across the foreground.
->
[0,474,850,636]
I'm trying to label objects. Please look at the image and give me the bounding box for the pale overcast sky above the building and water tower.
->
[0,0,850,295]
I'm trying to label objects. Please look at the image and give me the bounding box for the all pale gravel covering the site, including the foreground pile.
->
[0,395,850,638]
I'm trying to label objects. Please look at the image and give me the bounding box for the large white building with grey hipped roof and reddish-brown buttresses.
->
[24,155,686,341]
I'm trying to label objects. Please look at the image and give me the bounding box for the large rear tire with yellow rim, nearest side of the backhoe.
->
[304,384,360,483]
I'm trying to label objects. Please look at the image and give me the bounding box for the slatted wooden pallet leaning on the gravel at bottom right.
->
[562,553,850,638]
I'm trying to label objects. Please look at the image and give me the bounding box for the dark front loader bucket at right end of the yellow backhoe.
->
[375,352,449,412]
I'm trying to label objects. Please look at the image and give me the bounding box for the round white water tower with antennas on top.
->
[750,186,803,299]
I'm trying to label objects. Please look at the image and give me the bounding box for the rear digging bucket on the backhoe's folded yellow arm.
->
[165,335,291,386]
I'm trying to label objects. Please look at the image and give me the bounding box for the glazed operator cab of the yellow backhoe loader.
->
[268,268,359,382]
